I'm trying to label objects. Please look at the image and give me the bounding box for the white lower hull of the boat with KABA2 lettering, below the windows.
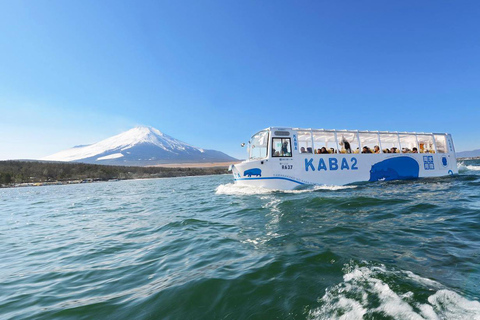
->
[231,153,458,190]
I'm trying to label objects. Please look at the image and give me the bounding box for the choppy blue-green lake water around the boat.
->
[0,161,480,320]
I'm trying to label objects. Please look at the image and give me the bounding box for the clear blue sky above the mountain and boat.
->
[0,0,480,159]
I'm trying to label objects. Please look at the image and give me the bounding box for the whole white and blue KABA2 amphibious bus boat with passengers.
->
[230,127,458,190]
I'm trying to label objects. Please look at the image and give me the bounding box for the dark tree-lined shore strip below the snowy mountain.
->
[0,160,227,187]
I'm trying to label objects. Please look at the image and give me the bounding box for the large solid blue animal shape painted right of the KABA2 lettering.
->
[369,157,420,181]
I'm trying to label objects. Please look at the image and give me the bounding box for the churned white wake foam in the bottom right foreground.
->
[308,265,480,320]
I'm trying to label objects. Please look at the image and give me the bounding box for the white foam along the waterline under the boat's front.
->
[215,183,356,195]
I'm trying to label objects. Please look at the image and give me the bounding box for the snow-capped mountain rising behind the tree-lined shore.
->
[40,127,236,166]
